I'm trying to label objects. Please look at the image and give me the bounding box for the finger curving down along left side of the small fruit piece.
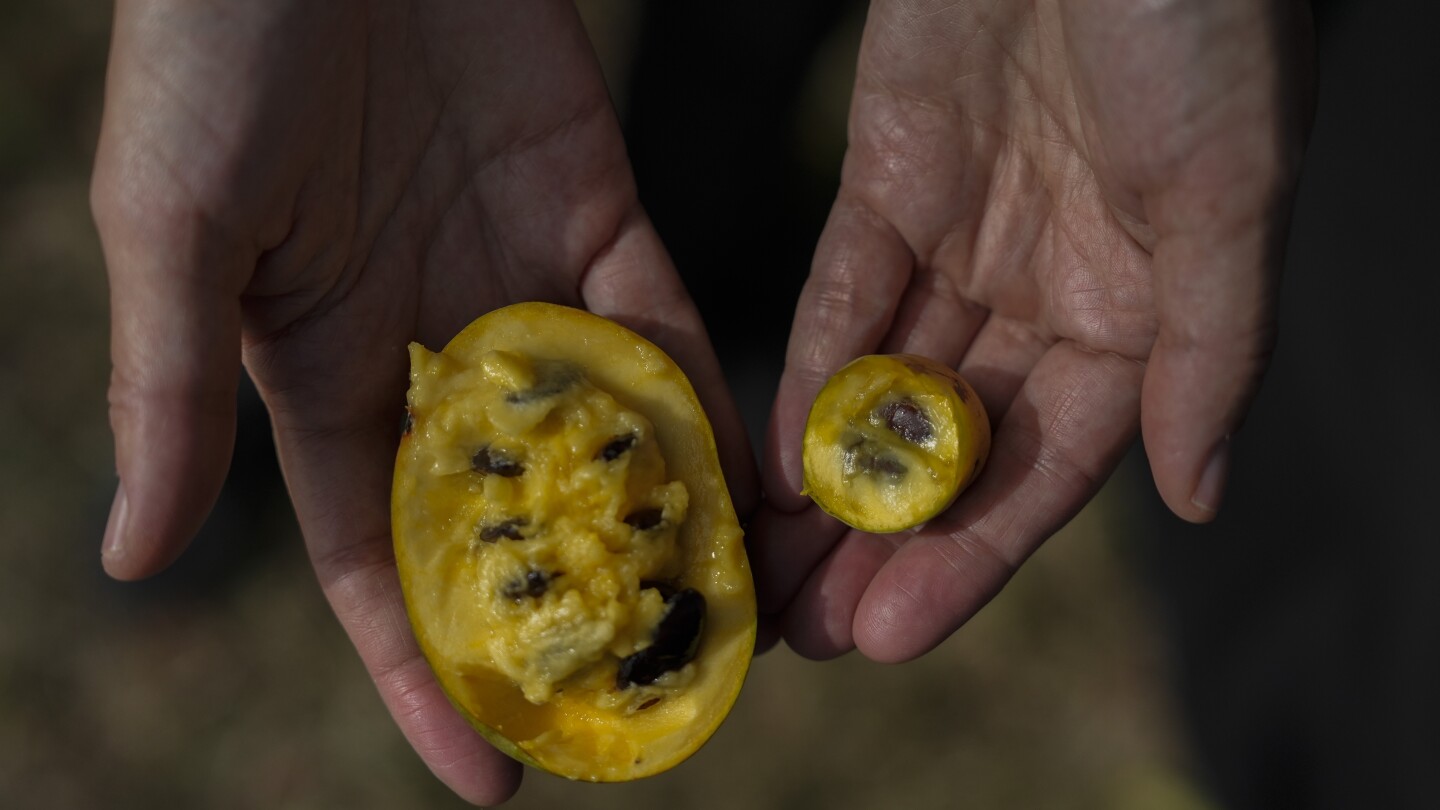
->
[765,192,914,512]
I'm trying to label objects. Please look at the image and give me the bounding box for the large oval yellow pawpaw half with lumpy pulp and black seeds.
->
[392,303,756,781]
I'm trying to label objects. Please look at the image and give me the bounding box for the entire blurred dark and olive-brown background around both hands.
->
[0,0,1440,810]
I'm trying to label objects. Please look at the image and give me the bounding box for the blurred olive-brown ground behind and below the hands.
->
[0,6,1210,810]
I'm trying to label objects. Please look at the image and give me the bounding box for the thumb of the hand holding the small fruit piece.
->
[1140,223,1279,522]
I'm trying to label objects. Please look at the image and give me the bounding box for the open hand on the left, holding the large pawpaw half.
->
[92,0,757,804]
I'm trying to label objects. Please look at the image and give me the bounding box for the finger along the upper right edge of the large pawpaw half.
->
[580,205,759,516]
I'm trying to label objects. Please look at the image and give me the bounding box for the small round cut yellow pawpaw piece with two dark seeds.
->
[804,355,991,533]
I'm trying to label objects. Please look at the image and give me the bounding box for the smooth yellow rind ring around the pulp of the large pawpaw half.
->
[392,303,756,781]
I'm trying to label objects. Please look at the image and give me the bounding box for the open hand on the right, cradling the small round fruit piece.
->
[753,0,1312,662]
